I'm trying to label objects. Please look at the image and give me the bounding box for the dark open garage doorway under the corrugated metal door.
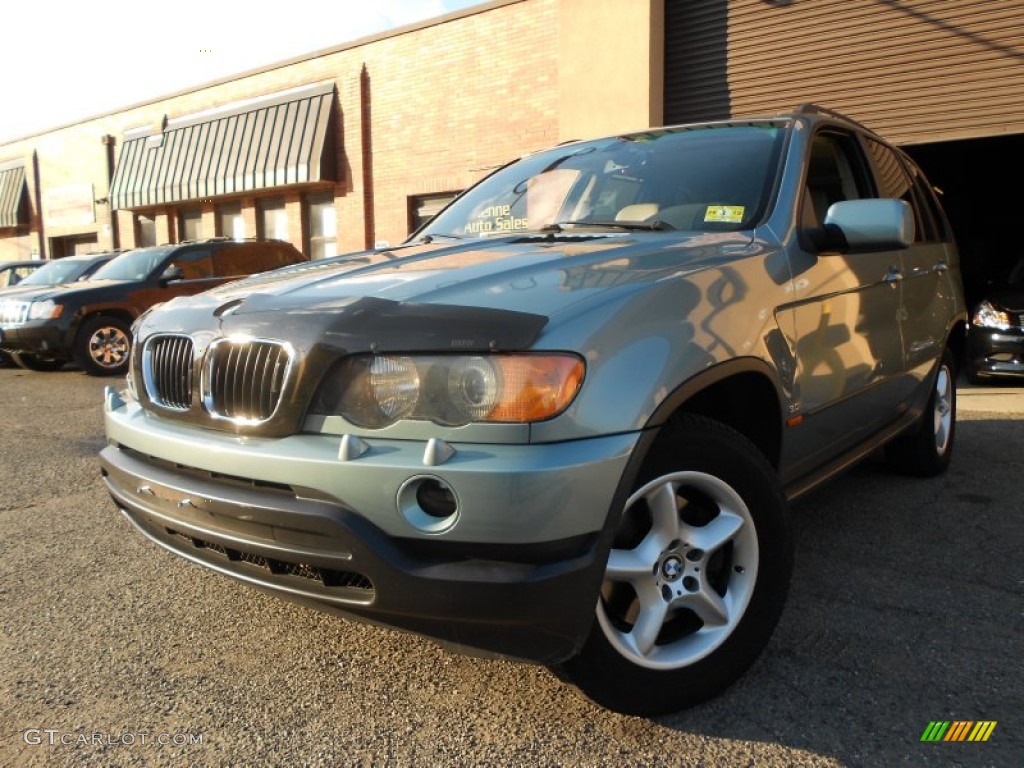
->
[903,134,1024,310]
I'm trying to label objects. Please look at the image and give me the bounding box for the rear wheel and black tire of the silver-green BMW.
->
[886,349,956,477]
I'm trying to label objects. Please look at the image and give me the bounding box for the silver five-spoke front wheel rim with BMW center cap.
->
[597,472,758,669]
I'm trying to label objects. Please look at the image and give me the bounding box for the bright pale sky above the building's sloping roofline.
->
[0,0,483,142]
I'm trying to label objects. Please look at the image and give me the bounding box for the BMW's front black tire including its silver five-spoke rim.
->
[558,416,793,716]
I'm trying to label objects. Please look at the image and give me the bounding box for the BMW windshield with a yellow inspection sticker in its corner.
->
[417,122,787,238]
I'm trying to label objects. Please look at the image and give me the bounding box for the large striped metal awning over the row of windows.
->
[111,82,334,208]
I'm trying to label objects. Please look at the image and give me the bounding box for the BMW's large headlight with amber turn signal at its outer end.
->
[312,353,585,429]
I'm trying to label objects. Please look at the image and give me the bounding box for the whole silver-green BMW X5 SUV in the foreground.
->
[101,105,966,714]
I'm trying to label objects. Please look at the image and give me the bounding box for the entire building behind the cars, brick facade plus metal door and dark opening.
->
[0,0,1024,296]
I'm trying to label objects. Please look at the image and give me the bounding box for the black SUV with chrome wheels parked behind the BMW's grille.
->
[0,238,308,376]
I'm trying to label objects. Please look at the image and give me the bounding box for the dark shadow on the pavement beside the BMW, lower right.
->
[659,414,1024,766]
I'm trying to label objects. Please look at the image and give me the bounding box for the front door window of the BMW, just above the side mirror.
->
[801,131,870,227]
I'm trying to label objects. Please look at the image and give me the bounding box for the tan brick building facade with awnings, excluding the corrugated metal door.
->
[0,0,660,260]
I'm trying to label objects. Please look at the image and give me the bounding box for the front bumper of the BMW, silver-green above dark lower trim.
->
[100,395,639,664]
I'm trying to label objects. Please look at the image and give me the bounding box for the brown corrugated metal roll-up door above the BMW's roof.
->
[665,0,1024,143]
